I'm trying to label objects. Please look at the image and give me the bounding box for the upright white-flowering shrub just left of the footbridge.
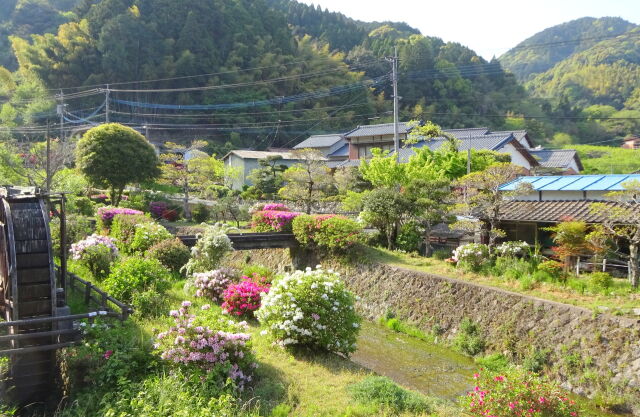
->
[184,223,233,274]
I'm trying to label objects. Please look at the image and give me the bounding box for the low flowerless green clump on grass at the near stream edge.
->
[349,375,434,414]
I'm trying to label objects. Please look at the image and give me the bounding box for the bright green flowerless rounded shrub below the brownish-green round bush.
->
[103,257,171,307]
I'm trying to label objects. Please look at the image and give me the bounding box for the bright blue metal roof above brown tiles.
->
[500,174,640,191]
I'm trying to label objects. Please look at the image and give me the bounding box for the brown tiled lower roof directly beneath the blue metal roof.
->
[502,200,640,223]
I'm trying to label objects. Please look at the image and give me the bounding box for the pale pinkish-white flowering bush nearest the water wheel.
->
[71,234,118,279]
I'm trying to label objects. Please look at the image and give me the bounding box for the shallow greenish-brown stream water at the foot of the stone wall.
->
[351,321,632,417]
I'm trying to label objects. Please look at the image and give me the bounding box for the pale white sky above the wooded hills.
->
[299,0,640,59]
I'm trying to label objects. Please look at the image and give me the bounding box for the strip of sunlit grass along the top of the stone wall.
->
[365,248,640,317]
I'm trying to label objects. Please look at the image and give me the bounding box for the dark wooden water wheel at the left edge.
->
[0,191,56,405]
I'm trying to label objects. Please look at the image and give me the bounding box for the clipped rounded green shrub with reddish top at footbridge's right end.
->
[292,214,362,250]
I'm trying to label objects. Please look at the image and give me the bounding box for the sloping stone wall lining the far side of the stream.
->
[222,250,640,415]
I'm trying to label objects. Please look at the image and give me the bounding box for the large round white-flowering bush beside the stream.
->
[256,268,360,355]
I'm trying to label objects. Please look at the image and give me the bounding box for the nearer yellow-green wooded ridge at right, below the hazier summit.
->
[527,27,640,109]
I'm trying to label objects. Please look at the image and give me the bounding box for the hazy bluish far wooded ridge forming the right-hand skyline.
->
[500,17,636,81]
